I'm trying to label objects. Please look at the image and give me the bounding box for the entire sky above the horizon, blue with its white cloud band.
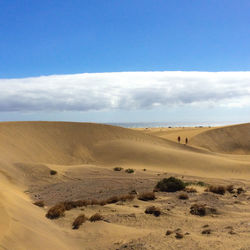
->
[0,0,250,124]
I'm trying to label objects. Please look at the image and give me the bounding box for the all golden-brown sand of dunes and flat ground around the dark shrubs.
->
[0,122,250,250]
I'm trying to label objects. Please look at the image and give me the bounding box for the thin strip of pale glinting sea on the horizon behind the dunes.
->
[105,122,240,128]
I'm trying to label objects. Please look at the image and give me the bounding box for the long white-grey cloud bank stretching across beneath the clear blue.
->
[0,71,250,112]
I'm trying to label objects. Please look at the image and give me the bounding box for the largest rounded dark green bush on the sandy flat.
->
[156,177,185,192]
